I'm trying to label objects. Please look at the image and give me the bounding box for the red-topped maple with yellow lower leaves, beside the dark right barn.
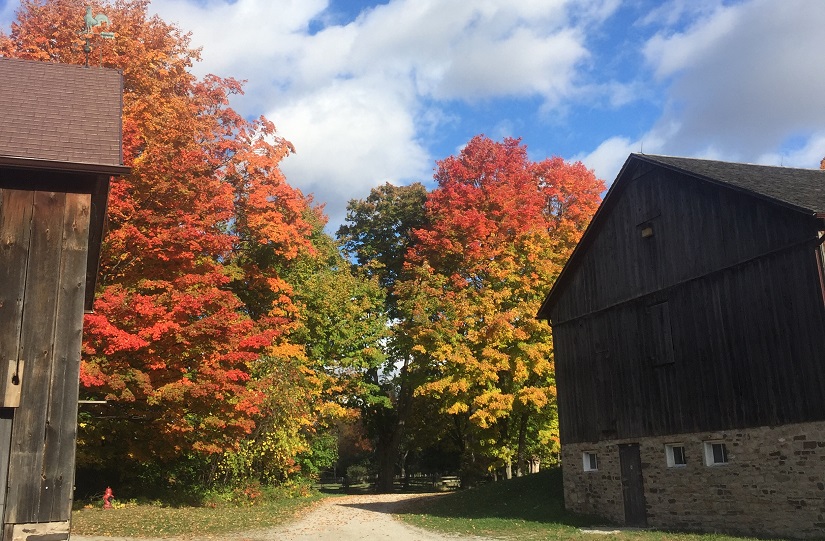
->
[398,136,604,473]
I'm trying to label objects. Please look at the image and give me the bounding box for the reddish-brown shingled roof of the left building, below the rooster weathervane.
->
[0,58,128,174]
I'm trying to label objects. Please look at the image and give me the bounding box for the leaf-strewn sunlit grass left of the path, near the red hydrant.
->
[72,489,323,537]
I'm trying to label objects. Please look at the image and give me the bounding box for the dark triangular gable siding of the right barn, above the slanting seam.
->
[552,167,813,323]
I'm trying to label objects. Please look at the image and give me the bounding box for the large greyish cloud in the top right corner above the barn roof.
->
[645,0,825,160]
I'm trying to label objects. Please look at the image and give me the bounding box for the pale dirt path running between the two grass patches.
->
[71,494,483,541]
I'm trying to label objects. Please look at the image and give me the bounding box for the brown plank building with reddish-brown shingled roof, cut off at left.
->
[0,58,128,541]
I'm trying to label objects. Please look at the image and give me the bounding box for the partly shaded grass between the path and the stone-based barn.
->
[399,469,780,541]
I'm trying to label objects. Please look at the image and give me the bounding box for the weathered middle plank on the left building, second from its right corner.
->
[6,192,66,523]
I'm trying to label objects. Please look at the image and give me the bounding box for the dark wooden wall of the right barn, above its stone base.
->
[551,163,825,442]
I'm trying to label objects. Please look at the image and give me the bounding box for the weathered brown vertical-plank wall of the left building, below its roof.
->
[0,189,91,540]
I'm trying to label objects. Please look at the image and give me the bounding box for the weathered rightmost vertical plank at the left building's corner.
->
[38,194,91,522]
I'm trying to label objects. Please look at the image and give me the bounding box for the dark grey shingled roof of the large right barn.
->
[640,154,825,214]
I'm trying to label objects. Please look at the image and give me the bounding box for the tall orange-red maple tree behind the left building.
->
[0,0,315,459]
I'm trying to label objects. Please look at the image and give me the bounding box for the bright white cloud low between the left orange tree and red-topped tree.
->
[274,79,432,230]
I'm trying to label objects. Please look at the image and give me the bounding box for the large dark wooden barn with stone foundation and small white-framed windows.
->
[539,154,825,538]
